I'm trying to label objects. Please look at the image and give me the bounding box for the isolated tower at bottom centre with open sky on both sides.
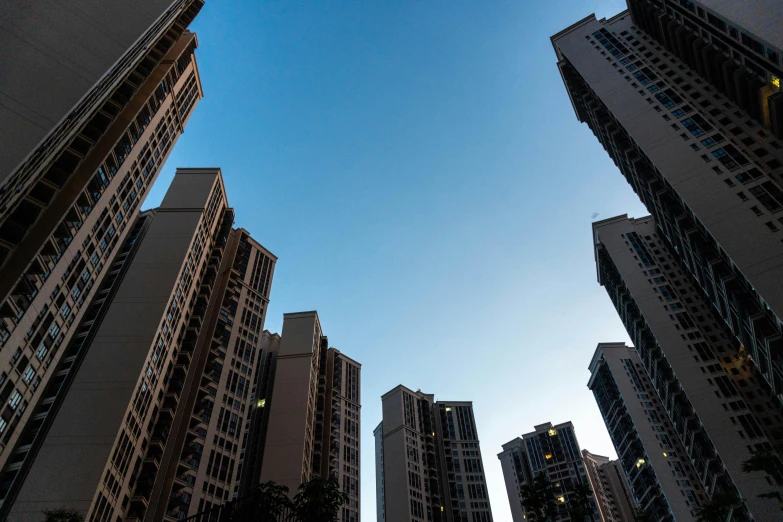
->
[375,385,492,522]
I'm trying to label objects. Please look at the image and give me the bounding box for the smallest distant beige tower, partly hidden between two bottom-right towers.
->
[582,450,636,522]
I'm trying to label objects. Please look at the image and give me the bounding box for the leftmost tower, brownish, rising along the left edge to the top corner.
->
[0,0,202,504]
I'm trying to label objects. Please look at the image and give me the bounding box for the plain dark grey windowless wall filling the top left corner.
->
[0,0,174,182]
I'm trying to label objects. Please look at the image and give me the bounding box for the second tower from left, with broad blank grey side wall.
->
[3,169,276,522]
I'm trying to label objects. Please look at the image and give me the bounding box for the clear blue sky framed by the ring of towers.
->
[145,0,645,522]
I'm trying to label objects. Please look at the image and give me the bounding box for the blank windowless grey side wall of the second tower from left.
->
[10,172,217,521]
